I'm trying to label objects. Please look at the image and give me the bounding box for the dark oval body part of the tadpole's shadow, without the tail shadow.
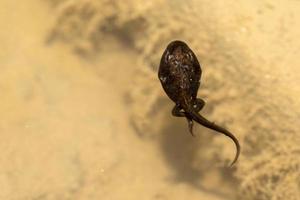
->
[160,118,206,183]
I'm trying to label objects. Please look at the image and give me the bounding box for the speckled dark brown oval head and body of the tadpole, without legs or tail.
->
[158,41,201,104]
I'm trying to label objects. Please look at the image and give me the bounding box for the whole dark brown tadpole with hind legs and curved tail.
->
[158,40,240,165]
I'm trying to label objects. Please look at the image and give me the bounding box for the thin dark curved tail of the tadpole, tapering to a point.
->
[189,108,240,166]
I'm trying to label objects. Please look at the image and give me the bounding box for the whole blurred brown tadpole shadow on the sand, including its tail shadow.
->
[160,117,236,199]
